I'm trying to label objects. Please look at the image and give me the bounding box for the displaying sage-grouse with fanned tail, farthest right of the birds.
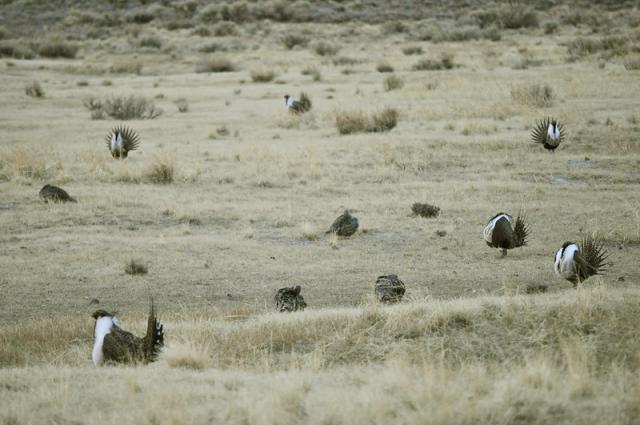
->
[554,236,608,287]
